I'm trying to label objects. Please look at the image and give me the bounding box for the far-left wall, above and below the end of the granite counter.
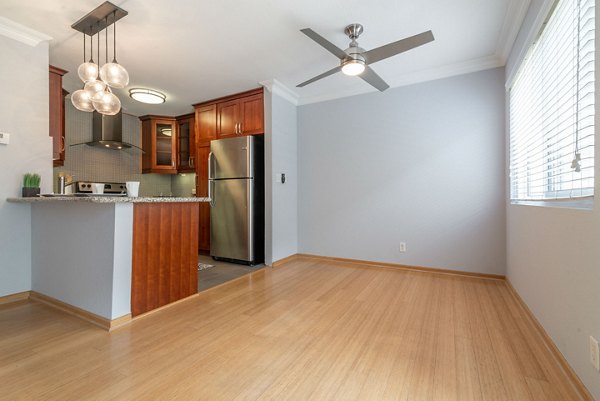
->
[0,35,52,296]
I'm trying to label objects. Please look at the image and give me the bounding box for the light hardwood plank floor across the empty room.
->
[0,260,581,401]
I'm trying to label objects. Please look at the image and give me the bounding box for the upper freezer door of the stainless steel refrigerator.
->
[210,136,254,179]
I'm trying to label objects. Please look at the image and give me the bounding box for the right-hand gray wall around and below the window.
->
[507,0,600,400]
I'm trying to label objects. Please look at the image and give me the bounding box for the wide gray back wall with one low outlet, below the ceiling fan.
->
[298,69,505,274]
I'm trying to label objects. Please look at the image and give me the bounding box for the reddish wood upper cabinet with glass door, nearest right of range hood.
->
[140,116,177,174]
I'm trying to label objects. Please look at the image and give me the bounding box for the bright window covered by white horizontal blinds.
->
[509,0,595,201]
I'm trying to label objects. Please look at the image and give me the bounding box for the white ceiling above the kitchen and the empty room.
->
[0,0,529,115]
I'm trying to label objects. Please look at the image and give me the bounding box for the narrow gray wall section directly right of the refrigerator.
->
[265,83,298,264]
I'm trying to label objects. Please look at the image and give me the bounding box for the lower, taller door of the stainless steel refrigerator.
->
[209,179,254,262]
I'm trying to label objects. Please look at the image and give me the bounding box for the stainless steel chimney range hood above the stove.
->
[71,111,143,152]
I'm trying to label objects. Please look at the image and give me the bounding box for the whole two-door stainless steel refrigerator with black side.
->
[208,136,265,265]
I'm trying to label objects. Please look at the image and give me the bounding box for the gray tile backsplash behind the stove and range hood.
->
[54,99,195,196]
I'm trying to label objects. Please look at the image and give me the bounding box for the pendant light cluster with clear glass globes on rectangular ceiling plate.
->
[71,1,129,115]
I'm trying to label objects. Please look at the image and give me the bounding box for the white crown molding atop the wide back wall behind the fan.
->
[298,55,504,106]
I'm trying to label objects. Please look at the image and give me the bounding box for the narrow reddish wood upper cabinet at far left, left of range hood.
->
[48,65,69,167]
